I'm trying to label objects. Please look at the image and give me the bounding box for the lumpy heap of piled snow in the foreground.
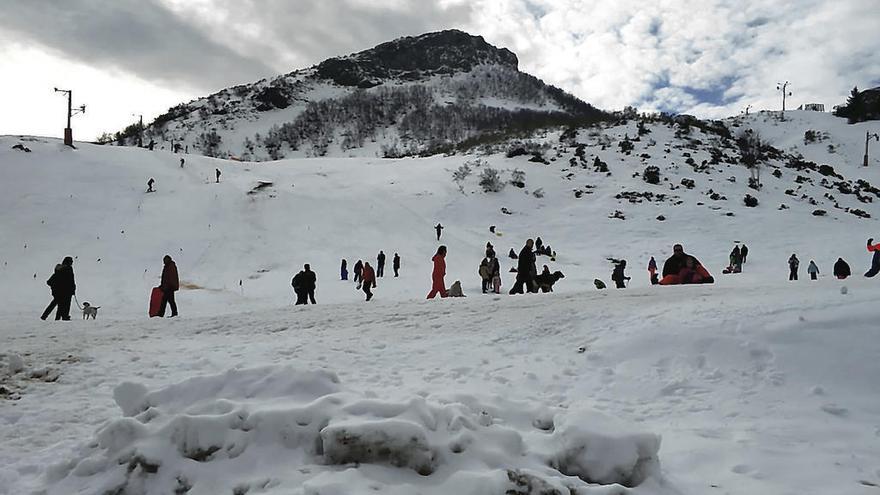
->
[46,366,671,494]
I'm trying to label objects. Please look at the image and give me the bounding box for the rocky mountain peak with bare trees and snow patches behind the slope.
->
[119,30,604,160]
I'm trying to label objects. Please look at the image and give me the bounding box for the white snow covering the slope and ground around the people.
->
[0,113,880,494]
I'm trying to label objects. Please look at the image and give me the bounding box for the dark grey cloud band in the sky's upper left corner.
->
[0,0,274,88]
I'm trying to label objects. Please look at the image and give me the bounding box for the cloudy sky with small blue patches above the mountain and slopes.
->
[0,0,880,139]
